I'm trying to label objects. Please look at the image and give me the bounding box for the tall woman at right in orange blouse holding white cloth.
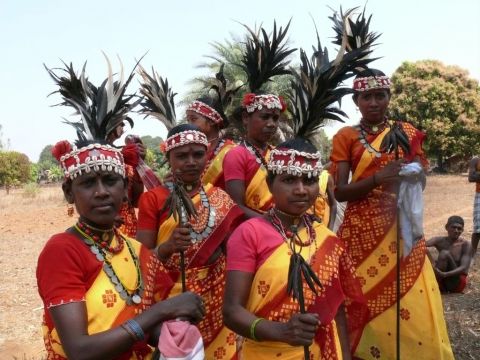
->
[331,69,453,360]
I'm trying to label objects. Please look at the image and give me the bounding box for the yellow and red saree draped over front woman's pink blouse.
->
[239,223,361,360]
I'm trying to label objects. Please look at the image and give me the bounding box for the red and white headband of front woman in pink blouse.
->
[267,148,323,177]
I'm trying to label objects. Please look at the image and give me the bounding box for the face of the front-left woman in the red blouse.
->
[62,171,127,228]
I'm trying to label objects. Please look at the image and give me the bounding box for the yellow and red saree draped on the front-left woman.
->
[37,234,171,359]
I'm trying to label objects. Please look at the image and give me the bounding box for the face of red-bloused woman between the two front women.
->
[168,144,207,184]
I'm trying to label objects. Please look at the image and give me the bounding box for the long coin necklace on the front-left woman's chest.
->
[74,222,144,305]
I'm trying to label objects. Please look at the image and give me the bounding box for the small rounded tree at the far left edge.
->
[0,151,30,194]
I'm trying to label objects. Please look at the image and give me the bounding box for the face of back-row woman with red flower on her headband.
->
[243,108,280,145]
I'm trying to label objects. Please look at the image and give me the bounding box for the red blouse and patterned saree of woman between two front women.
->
[138,184,243,360]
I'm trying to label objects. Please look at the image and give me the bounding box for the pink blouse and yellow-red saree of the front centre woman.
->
[227,218,367,360]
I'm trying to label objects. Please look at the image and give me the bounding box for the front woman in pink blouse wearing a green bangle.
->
[223,139,366,360]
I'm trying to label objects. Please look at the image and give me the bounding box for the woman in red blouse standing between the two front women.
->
[138,124,243,359]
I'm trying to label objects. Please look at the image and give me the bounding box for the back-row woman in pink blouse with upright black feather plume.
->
[223,24,295,218]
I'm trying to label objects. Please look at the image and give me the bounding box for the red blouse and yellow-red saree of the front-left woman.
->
[37,232,173,360]
